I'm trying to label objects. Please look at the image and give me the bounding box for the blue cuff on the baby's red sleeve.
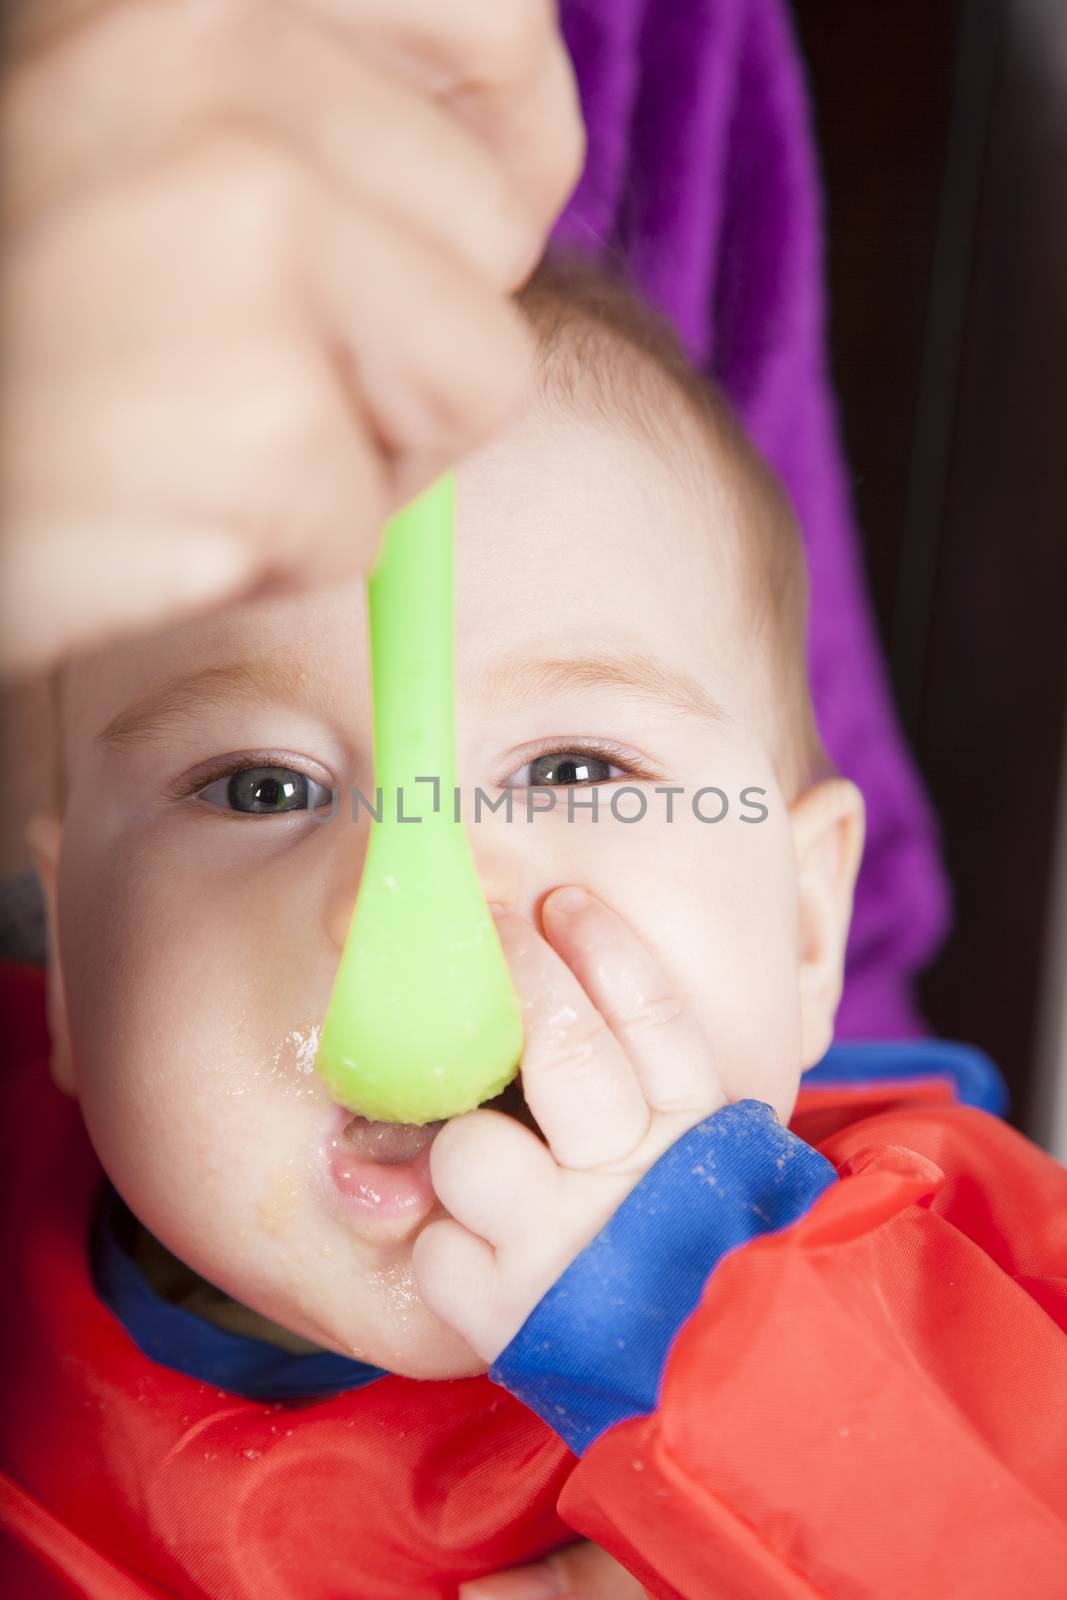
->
[490,1101,837,1454]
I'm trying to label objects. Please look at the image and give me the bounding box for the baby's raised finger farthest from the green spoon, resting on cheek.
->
[541,886,725,1115]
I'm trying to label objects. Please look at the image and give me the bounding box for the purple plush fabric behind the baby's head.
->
[557,0,947,1038]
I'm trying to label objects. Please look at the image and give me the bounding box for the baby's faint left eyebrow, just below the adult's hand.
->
[96,653,321,749]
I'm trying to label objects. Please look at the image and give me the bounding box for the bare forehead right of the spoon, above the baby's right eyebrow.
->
[456,397,739,654]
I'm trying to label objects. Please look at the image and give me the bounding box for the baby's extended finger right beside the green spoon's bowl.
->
[496,912,649,1171]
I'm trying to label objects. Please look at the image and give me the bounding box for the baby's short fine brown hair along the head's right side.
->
[517,253,833,798]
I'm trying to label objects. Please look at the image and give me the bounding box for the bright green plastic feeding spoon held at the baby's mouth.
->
[315,472,523,1123]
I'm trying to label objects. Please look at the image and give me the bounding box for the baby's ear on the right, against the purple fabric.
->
[789,778,864,1069]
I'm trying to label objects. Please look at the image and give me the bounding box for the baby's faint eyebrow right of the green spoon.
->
[485,654,731,725]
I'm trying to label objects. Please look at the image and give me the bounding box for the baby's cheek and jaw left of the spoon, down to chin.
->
[51,830,524,1378]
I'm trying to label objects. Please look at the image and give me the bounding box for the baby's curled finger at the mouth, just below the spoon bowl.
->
[430,1110,558,1246]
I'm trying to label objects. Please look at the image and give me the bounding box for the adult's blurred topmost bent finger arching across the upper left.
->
[3,5,542,290]
